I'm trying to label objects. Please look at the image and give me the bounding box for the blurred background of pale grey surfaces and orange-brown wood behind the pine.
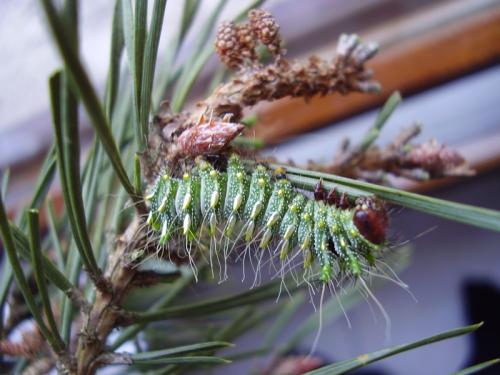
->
[0,0,500,374]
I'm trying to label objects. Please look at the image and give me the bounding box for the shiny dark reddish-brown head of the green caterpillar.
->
[353,203,389,244]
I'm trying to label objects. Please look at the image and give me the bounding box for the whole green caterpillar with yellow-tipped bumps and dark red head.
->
[147,155,388,283]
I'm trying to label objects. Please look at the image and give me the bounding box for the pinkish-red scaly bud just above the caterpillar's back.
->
[177,120,245,157]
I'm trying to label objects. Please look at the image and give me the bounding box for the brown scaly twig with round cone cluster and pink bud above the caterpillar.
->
[149,10,380,176]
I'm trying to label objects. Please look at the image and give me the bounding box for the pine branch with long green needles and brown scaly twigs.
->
[0,0,500,374]
